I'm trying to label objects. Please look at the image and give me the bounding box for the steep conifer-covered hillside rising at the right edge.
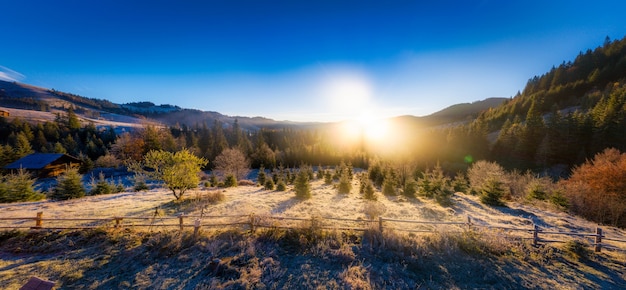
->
[470,37,626,170]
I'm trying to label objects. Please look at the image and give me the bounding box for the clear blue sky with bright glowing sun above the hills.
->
[0,0,626,121]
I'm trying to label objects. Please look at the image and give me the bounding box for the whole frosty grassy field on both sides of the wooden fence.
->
[0,181,626,289]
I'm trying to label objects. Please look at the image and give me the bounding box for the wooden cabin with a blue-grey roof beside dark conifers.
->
[4,153,82,178]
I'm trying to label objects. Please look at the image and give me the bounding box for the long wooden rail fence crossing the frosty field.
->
[0,211,626,252]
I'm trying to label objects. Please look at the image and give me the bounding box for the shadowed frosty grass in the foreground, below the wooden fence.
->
[0,223,626,289]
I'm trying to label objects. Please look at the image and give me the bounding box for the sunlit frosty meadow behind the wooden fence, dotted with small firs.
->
[0,180,626,237]
